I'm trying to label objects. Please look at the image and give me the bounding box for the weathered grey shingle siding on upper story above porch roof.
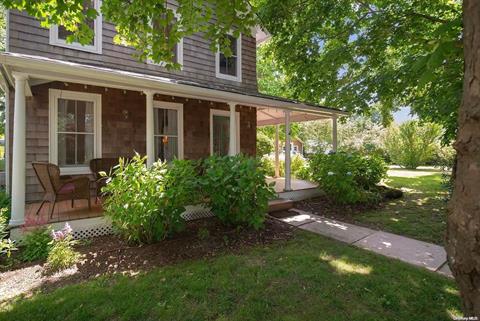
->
[9,10,257,93]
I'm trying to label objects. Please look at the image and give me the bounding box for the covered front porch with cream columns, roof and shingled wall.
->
[0,54,344,227]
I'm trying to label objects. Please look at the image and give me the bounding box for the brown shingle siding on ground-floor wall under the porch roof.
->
[10,82,257,202]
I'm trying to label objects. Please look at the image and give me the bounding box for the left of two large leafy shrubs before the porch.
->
[103,155,198,243]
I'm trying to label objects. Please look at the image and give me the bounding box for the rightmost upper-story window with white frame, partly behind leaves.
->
[215,34,242,82]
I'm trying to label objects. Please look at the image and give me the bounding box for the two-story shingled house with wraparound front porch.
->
[0,0,343,235]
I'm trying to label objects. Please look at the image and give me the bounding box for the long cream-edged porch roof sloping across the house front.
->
[0,52,348,119]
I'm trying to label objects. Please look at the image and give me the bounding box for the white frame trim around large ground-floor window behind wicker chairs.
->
[48,89,102,175]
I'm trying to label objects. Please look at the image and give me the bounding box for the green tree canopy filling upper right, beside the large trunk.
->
[256,0,463,139]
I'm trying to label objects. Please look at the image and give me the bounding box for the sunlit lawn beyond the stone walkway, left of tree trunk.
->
[355,171,447,245]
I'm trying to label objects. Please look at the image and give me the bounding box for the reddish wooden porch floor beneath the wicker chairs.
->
[25,197,103,225]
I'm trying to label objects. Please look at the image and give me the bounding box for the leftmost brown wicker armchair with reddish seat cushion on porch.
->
[32,163,91,218]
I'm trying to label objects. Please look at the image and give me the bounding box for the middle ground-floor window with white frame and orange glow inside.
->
[153,101,183,162]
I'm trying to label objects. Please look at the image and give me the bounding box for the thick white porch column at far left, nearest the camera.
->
[7,74,28,226]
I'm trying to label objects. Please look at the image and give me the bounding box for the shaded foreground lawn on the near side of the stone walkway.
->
[0,231,460,321]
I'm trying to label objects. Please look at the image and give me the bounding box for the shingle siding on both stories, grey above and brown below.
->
[8,1,257,202]
